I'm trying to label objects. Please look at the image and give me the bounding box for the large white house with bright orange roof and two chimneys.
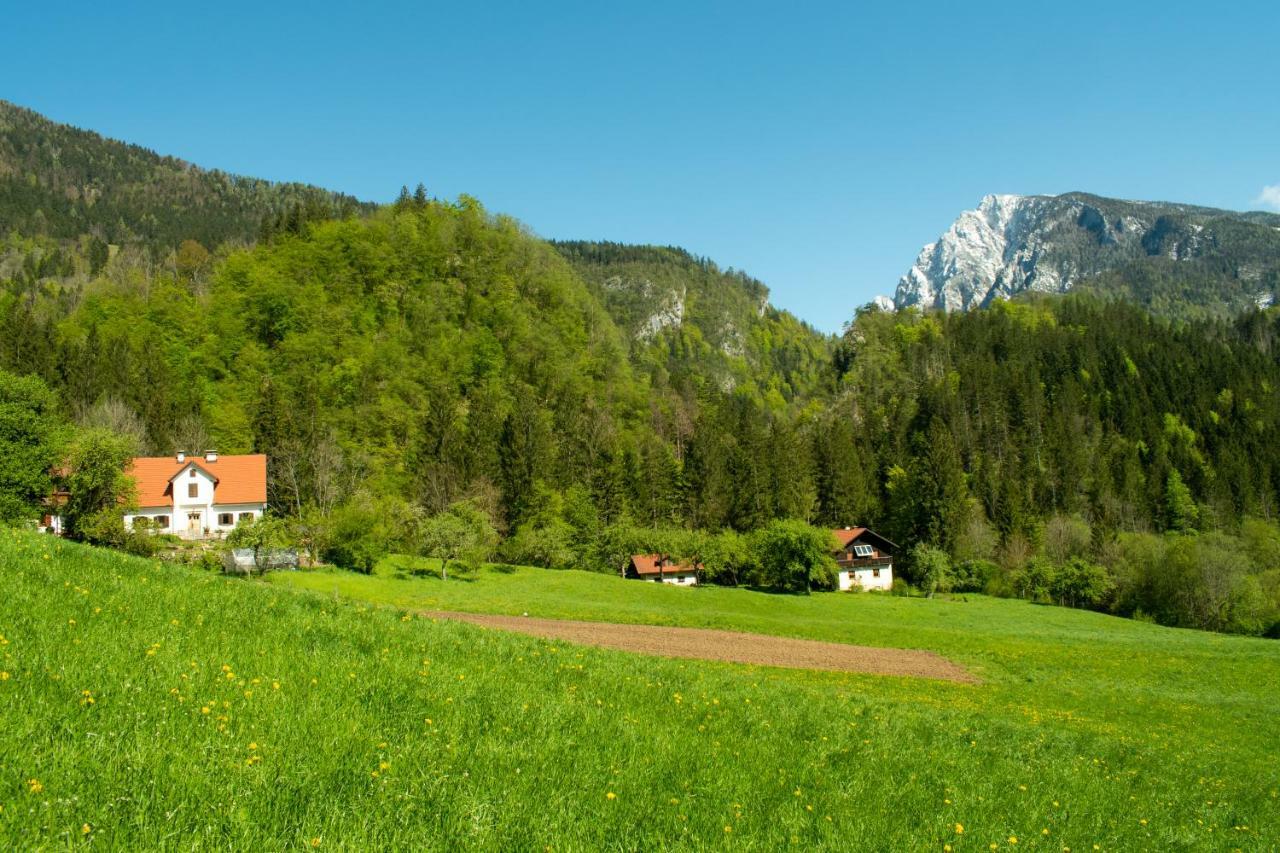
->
[124,451,266,539]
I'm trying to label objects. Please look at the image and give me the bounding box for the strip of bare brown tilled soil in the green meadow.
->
[424,611,978,684]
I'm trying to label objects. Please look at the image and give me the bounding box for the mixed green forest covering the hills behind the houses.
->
[0,99,1280,634]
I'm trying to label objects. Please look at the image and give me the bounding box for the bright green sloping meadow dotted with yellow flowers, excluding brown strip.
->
[0,532,1280,850]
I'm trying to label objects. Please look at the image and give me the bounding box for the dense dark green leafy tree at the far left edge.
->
[0,370,67,523]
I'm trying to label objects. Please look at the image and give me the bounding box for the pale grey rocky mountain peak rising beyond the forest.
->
[893,192,1280,311]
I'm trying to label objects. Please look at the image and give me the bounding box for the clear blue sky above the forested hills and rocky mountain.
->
[0,0,1280,330]
